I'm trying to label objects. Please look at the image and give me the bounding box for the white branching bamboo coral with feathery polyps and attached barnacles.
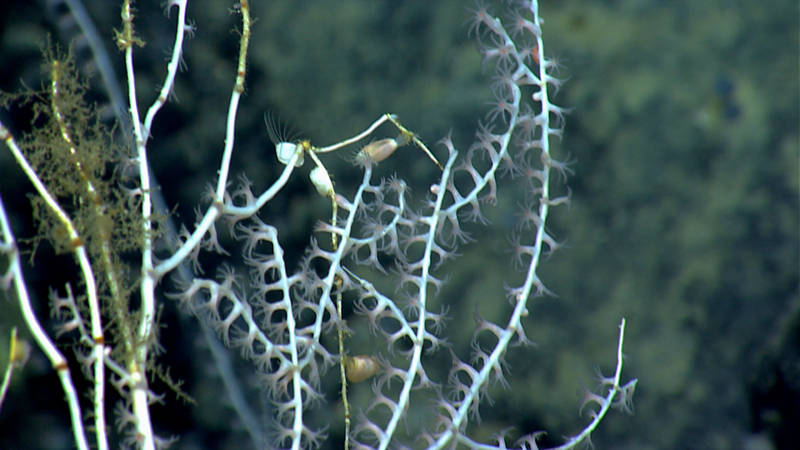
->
[0,0,636,449]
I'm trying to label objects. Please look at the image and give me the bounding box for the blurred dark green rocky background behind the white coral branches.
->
[0,0,800,449]
